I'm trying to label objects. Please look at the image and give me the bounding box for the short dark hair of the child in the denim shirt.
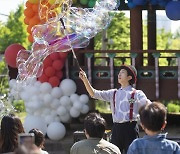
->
[139,102,167,132]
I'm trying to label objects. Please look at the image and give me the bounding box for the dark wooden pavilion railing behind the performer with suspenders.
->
[66,50,180,100]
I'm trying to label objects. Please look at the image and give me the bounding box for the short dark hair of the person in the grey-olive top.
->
[84,113,106,138]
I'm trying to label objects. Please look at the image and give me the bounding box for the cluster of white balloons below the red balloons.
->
[9,79,89,140]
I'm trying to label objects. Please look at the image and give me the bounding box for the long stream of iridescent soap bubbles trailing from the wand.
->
[17,0,118,81]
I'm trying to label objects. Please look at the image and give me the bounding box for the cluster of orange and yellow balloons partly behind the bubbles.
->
[24,0,66,42]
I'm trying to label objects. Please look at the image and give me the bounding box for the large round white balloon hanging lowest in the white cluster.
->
[47,122,66,141]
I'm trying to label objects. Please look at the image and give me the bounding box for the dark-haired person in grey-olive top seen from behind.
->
[70,113,121,154]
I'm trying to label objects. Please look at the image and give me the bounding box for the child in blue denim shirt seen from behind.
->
[127,102,180,154]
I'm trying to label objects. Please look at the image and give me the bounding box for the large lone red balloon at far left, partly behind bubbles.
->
[4,44,25,68]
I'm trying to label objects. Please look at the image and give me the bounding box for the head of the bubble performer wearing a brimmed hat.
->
[118,65,137,85]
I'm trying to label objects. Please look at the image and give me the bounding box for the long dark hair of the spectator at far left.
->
[1,114,24,153]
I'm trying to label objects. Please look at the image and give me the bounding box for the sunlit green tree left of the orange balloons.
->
[0,4,30,52]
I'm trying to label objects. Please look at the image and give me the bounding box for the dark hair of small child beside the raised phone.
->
[29,129,45,147]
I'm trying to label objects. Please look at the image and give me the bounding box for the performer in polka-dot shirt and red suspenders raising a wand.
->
[79,65,148,153]
